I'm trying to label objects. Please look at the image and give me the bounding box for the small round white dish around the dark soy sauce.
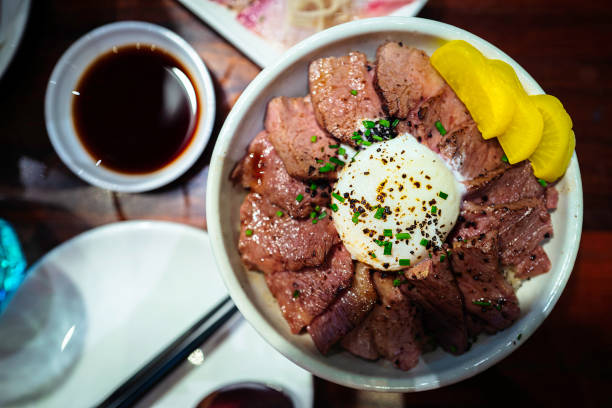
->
[45,21,215,192]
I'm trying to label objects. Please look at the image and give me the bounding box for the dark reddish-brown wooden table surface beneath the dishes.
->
[0,0,612,407]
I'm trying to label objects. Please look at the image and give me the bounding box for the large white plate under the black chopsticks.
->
[0,221,312,408]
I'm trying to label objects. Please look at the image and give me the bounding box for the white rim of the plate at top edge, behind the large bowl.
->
[178,0,427,68]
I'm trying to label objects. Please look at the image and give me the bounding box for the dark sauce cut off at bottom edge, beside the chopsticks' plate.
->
[196,383,294,408]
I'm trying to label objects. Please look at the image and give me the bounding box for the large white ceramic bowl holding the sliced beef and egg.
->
[207,17,583,391]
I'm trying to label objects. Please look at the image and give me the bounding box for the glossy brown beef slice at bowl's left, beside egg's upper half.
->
[232,131,330,218]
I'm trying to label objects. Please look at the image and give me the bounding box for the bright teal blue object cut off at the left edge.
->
[0,219,27,314]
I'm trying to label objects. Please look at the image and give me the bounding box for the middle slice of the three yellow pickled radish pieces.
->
[487,60,544,164]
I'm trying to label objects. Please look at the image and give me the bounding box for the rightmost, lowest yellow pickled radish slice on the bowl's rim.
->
[529,95,576,182]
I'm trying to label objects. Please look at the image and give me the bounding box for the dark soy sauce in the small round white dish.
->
[72,44,200,174]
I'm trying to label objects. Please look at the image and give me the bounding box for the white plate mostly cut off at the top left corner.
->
[0,0,30,78]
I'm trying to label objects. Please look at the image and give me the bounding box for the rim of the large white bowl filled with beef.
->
[206,17,583,392]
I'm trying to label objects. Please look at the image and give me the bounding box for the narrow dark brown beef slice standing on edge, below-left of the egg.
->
[308,262,377,354]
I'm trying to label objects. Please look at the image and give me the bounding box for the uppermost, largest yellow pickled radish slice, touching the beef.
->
[431,40,515,139]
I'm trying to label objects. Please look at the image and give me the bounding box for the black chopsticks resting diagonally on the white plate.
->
[98,296,238,408]
